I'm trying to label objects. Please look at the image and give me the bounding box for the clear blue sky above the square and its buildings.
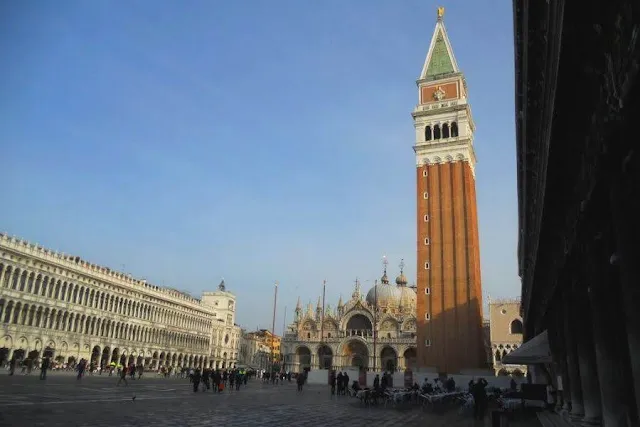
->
[0,0,520,331]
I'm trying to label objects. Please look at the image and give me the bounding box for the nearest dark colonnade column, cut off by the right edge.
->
[610,163,640,417]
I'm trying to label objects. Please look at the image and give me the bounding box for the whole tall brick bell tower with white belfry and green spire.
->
[412,8,486,373]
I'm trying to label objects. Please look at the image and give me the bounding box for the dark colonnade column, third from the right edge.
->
[572,278,602,425]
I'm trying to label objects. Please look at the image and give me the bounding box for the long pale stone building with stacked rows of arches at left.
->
[0,234,240,369]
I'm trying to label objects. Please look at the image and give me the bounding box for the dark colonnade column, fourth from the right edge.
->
[563,289,584,420]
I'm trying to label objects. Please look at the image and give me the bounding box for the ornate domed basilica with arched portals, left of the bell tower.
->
[282,264,416,372]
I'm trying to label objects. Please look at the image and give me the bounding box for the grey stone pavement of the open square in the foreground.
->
[0,372,524,427]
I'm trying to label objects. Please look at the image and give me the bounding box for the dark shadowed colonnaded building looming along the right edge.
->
[509,0,640,426]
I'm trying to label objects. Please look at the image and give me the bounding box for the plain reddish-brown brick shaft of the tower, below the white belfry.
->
[416,162,486,373]
